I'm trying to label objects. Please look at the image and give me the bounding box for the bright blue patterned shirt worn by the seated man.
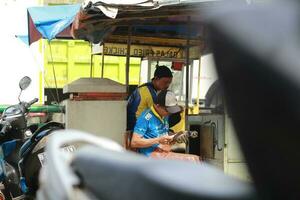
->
[133,109,169,156]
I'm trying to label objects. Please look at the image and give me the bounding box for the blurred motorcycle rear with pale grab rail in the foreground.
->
[36,130,255,200]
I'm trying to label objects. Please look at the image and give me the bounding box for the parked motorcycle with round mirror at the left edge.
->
[0,76,64,199]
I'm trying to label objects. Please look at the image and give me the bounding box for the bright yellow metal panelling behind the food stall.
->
[44,40,141,88]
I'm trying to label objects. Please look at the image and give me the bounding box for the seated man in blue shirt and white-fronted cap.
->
[131,90,200,162]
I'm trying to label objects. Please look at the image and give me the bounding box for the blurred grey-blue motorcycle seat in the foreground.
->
[72,146,256,200]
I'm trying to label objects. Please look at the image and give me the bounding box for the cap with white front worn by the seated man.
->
[156,90,181,113]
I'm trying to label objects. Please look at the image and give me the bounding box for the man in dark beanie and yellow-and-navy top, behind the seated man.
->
[124,66,173,148]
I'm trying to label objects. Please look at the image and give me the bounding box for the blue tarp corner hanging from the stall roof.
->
[28,4,80,40]
